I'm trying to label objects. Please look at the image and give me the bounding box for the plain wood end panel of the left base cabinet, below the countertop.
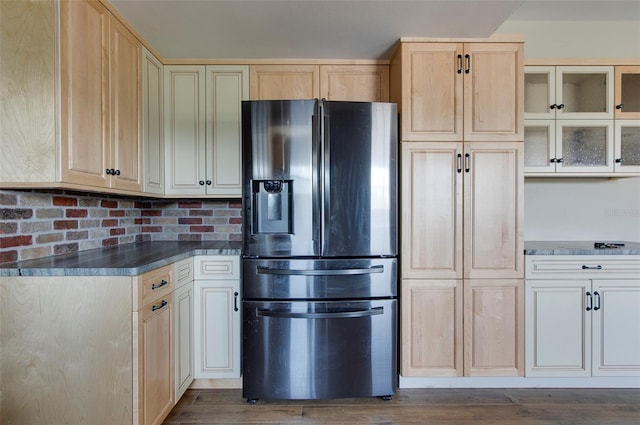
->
[0,276,133,424]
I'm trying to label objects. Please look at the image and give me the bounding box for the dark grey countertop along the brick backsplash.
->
[0,241,242,276]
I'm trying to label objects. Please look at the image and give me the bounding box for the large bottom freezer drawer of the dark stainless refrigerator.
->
[242,300,397,399]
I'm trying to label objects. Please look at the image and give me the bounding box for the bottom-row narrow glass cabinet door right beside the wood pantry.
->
[524,120,556,174]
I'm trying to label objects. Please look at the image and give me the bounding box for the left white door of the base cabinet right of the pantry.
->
[525,280,591,377]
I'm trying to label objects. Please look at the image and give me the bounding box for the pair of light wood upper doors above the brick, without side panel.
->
[60,0,142,191]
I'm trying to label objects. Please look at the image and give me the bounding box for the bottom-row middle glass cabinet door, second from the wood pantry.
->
[555,120,613,173]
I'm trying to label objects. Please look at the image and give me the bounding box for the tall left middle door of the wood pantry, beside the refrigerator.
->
[401,142,462,279]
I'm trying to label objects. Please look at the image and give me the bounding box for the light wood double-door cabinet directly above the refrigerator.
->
[249,64,389,102]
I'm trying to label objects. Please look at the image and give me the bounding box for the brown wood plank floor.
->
[164,388,640,425]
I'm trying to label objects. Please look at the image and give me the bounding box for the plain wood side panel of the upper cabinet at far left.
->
[0,1,58,182]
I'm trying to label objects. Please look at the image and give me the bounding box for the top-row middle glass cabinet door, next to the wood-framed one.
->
[551,66,613,119]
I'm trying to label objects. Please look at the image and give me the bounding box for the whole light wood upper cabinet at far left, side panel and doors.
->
[0,0,142,193]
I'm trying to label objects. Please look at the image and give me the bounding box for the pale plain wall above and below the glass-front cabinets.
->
[496,20,640,242]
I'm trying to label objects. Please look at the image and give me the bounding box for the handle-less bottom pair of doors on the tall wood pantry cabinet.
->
[400,279,524,377]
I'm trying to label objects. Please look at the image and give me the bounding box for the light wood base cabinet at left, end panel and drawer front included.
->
[0,265,180,425]
